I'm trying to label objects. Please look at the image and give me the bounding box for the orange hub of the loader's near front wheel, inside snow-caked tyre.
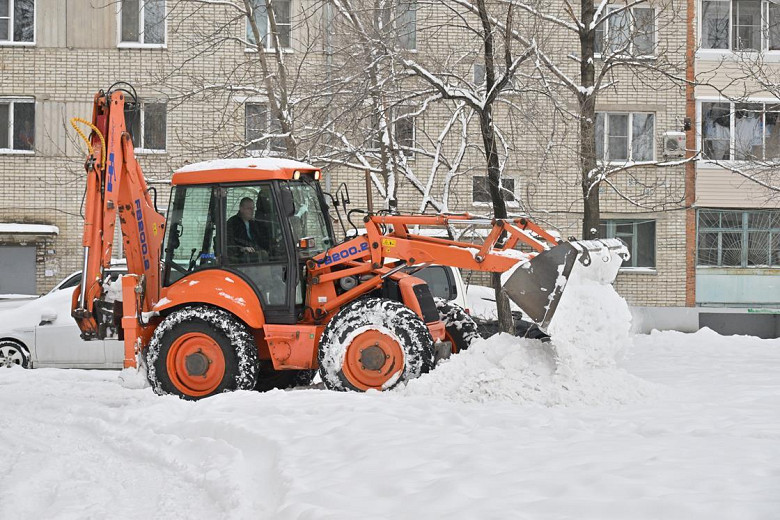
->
[342,330,404,390]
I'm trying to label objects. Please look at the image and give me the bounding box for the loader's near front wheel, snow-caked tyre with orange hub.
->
[318,298,433,392]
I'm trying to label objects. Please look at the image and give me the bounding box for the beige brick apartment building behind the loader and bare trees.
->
[6,0,764,334]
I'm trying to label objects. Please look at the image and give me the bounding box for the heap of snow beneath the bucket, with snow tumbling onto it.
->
[400,273,656,406]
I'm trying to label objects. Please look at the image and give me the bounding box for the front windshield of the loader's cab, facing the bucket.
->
[288,181,333,256]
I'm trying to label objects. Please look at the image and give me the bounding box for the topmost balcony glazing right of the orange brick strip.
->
[701,0,780,51]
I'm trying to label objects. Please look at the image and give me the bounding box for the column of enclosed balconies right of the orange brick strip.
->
[695,0,780,337]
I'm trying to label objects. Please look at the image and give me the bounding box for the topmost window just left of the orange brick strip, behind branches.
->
[594,7,655,56]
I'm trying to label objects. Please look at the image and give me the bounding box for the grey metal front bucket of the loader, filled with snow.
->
[501,238,629,330]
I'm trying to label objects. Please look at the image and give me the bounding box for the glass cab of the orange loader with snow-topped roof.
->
[162,159,334,324]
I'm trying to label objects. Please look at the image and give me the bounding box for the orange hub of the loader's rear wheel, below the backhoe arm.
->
[166,332,225,397]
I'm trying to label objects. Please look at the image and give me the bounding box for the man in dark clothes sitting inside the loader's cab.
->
[227,197,269,264]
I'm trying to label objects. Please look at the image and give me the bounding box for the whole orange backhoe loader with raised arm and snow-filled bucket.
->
[68,84,627,399]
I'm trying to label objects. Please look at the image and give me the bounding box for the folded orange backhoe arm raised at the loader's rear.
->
[72,90,165,339]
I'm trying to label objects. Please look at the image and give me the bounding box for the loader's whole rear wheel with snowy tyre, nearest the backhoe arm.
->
[146,305,258,400]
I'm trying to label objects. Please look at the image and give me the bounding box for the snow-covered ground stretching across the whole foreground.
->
[0,330,780,520]
